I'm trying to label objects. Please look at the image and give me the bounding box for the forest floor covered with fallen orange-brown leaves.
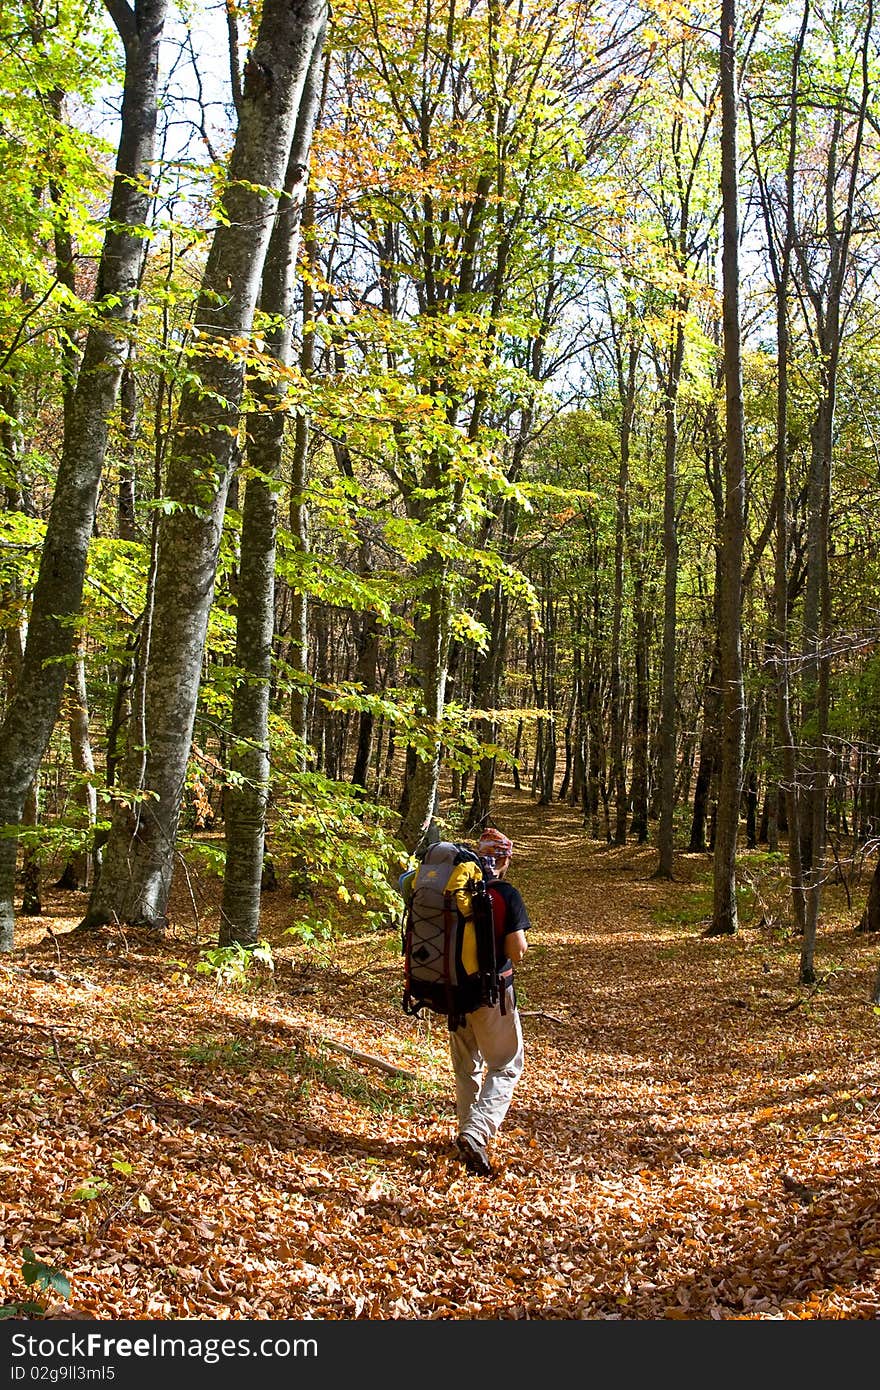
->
[0,788,880,1319]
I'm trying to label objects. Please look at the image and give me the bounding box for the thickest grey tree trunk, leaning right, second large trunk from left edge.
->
[83,0,325,927]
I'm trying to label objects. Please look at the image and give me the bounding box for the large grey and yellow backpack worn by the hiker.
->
[403,840,506,1030]
